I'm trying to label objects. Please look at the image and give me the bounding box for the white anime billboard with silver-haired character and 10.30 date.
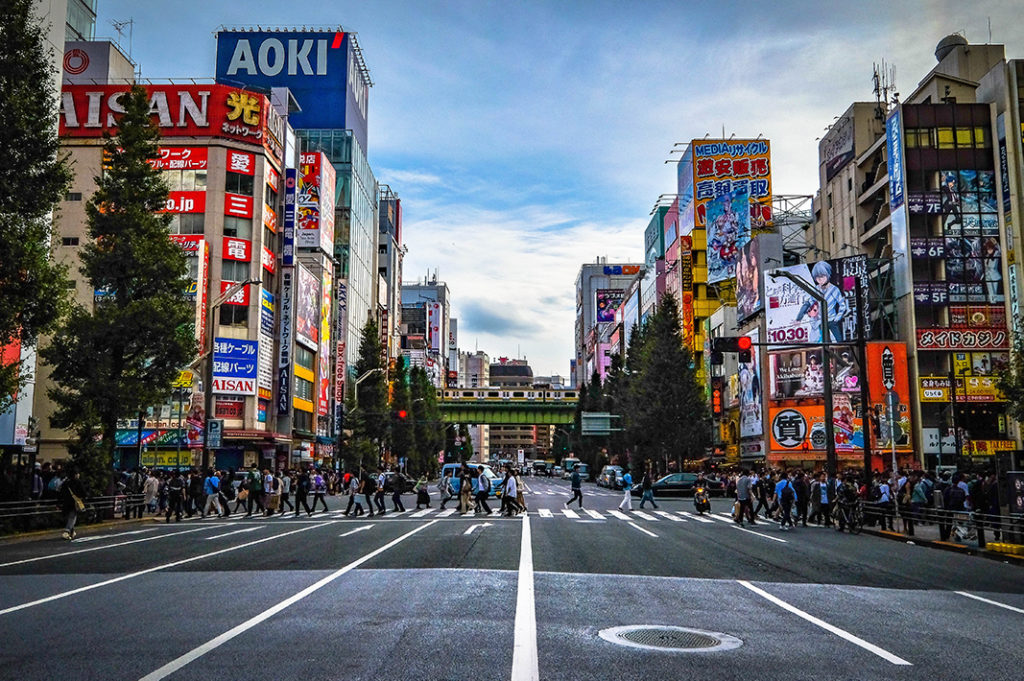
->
[764,255,870,343]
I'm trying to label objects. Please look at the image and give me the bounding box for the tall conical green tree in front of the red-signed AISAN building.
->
[42,86,197,489]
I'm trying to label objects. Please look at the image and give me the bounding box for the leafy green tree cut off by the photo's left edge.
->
[0,0,72,412]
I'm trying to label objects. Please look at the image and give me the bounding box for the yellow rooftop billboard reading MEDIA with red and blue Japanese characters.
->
[679,139,772,229]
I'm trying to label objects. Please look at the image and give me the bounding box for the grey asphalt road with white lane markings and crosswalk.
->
[0,478,1024,681]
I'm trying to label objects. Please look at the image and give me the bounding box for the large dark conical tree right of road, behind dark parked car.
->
[631,294,711,470]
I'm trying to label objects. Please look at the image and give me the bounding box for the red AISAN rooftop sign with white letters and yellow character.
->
[60,84,270,145]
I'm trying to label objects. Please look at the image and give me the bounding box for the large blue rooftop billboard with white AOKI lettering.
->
[216,31,371,153]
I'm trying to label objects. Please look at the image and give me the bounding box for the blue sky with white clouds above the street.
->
[96,0,1024,375]
